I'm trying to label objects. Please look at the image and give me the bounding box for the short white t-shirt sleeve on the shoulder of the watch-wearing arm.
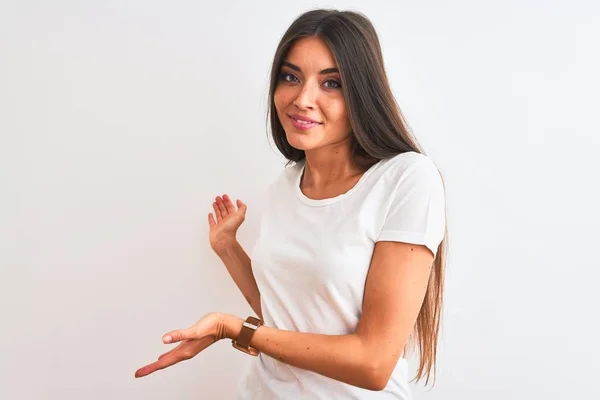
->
[377,154,446,257]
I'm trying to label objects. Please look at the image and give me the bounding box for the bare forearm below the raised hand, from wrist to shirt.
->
[215,240,262,319]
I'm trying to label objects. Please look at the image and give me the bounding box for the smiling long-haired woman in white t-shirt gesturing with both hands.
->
[136,10,446,399]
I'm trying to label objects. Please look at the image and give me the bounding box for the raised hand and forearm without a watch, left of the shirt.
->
[208,194,262,319]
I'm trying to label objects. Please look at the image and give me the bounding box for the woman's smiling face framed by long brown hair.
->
[274,38,350,151]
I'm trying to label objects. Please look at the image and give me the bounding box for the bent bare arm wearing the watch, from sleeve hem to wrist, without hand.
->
[226,242,433,390]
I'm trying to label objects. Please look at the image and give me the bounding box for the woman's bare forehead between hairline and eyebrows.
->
[285,37,337,72]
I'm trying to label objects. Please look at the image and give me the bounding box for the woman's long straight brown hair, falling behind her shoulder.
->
[267,9,447,384]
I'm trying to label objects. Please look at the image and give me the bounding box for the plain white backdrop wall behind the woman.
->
[0,0,600,400]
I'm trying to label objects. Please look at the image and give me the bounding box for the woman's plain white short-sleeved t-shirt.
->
[238,152,445,400]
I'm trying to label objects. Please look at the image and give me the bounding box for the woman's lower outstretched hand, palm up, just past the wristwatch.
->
[135,313,241,378]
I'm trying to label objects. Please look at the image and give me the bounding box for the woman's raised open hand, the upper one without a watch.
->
[208,194,247,253]
